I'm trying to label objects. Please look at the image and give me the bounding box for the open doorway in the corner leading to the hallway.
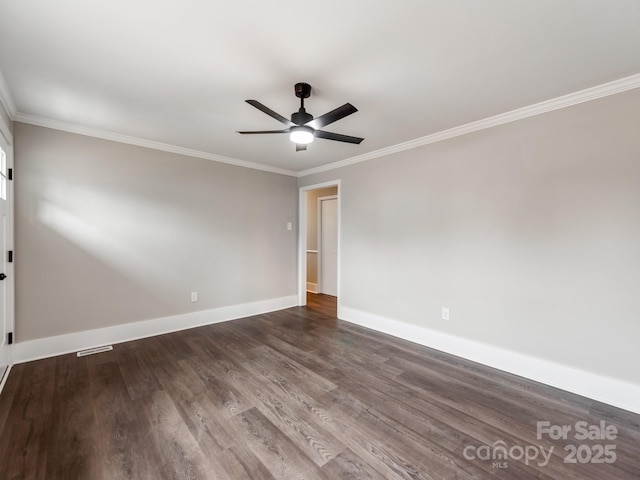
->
[298,181,340,317]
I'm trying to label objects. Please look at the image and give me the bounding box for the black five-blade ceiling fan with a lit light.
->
[238,83,364,152]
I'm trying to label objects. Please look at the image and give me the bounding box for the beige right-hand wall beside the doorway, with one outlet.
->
[299,90,640,384]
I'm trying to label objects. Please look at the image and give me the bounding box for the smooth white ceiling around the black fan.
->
[0,0,640,172]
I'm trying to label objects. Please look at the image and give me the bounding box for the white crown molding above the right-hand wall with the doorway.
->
[297,74,640,177]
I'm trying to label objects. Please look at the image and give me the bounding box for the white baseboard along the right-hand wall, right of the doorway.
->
[338,306,640,414]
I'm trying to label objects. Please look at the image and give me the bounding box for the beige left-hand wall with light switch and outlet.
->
[14,123,297,341]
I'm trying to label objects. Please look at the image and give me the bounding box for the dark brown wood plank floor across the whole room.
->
[0,296,640,480]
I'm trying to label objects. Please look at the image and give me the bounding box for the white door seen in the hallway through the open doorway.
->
[318,197,338,297]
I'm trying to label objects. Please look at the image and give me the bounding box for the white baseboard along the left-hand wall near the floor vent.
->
[12,295,298,363]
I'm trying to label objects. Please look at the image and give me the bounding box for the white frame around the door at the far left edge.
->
[0,113,15,392]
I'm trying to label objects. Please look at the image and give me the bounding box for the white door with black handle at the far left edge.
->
[0,132,13,381]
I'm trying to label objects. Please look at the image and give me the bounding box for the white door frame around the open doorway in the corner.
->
[298,180,342,312]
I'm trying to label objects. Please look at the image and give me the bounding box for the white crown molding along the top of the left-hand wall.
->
[13,112,298,177]
